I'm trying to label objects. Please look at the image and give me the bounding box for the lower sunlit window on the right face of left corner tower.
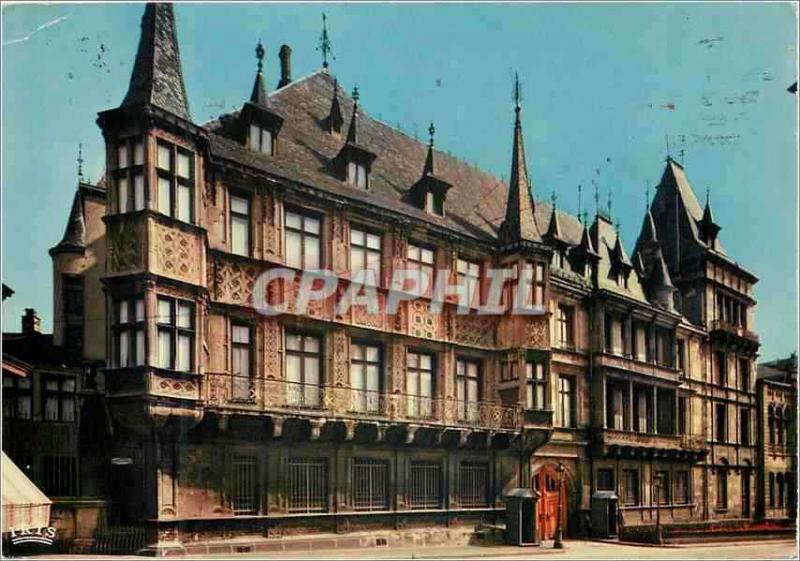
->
[156,297,194,372]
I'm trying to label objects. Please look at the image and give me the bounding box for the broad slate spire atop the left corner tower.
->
[121,3,191,121]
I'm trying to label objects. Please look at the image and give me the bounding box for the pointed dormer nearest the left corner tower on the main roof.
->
[239,41,283,156]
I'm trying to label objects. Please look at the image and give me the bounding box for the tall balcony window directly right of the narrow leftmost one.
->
[286,333,322,407]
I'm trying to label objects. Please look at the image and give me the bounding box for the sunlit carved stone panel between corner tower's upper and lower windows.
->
[152,223,202,283]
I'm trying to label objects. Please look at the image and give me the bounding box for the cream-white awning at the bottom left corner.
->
[2,452,52,534]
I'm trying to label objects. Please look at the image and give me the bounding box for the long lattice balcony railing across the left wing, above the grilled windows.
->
[203,373,524,430]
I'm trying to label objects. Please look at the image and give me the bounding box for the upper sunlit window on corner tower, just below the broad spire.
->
[156,141,194,223]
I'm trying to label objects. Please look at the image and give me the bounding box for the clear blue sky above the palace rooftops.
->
[2,3,798,358]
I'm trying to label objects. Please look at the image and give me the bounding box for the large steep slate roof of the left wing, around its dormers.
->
[204,70,510,241]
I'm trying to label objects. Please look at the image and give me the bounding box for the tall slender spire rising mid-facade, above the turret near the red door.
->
[500,74,540,243]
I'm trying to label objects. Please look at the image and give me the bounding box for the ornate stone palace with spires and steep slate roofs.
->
[31,4,761,552]
